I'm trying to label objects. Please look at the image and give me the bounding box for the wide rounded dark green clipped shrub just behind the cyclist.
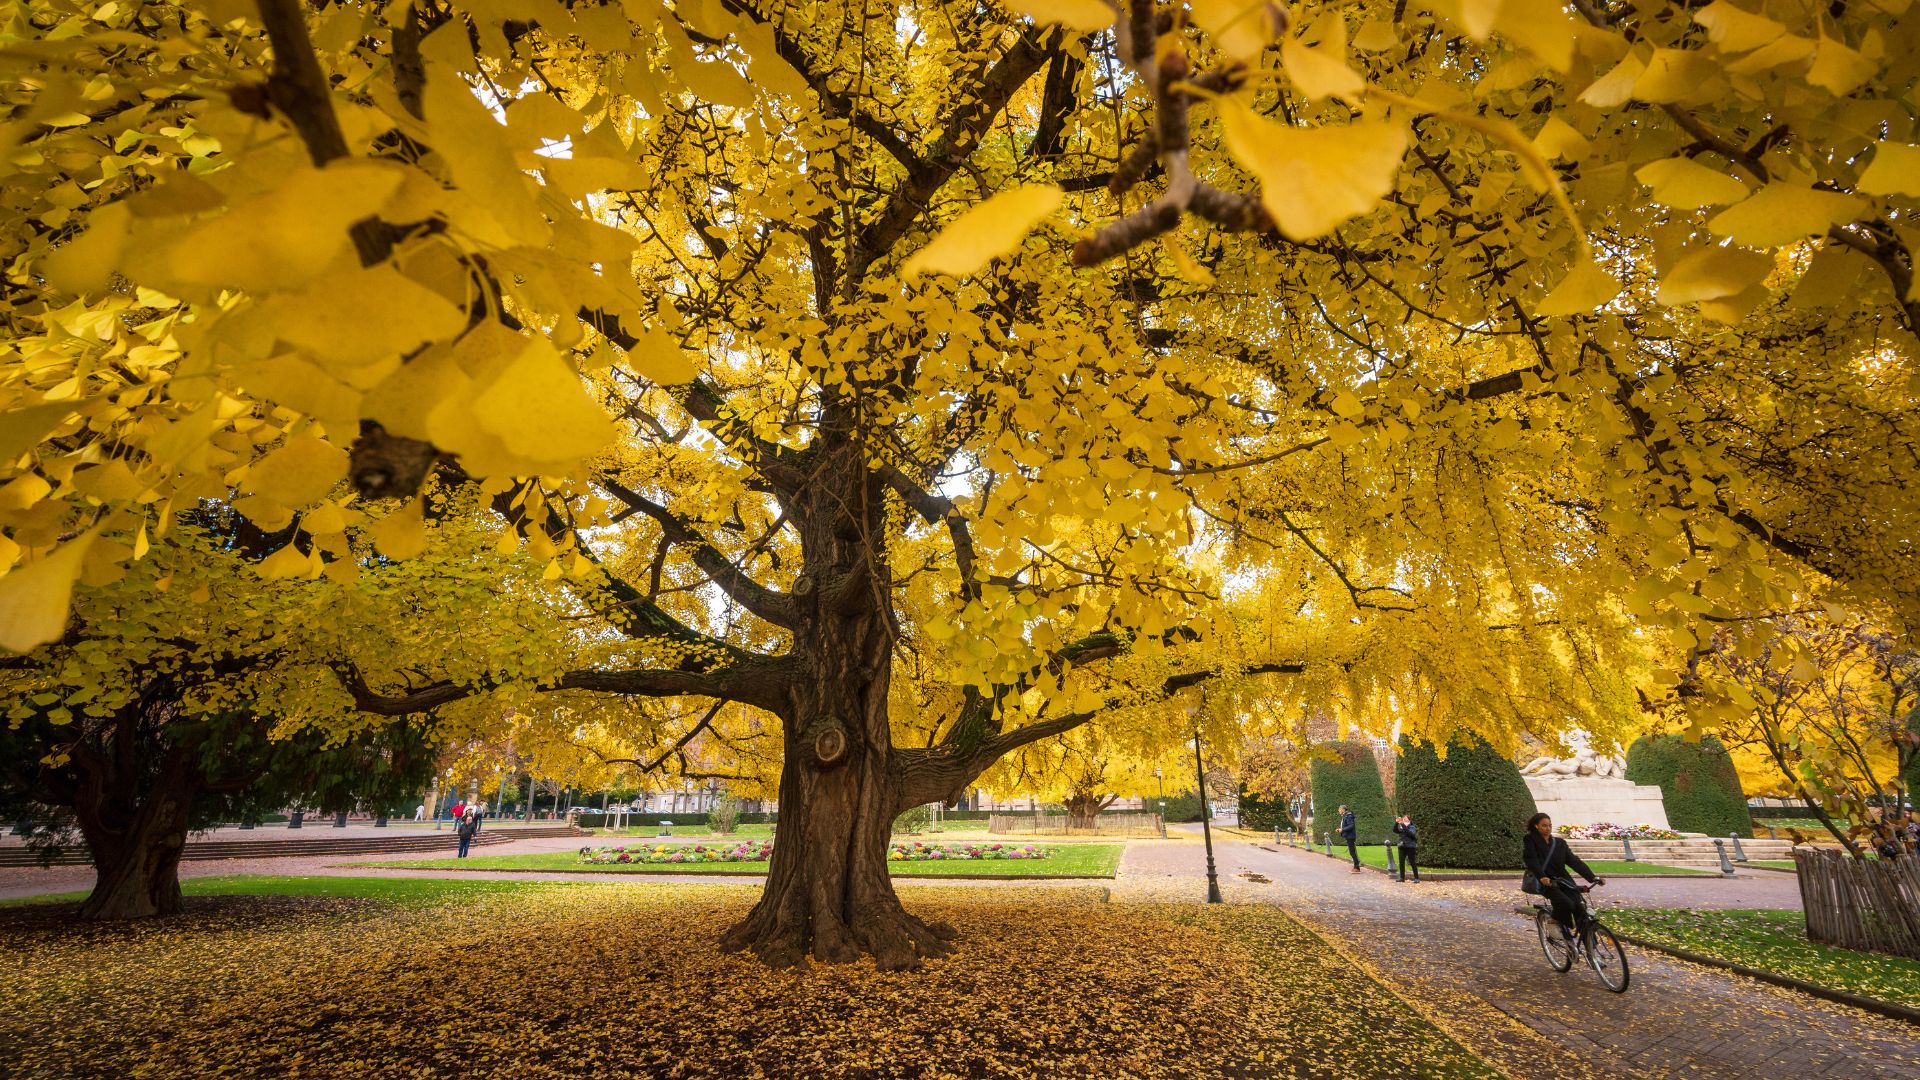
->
[1394,738,1536,871]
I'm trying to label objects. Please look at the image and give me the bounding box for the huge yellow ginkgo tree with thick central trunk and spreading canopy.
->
[0,0,1920,969]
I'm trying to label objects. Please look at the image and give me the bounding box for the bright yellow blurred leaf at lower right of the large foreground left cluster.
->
[472,338,614,465]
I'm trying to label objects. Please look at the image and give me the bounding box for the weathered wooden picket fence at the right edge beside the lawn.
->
[1793,844,1920,959]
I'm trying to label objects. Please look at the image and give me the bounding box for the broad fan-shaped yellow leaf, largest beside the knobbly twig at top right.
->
[1219,98,1407,240]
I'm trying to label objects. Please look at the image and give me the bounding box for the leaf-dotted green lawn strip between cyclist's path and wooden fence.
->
[1607,907,1920,1007]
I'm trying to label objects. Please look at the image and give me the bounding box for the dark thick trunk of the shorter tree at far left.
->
[77,764,192,919]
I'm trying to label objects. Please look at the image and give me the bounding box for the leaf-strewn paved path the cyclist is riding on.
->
[1114,836,1920,1080]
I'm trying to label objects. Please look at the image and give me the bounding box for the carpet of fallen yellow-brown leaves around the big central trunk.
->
[0,882,1490,1078]
